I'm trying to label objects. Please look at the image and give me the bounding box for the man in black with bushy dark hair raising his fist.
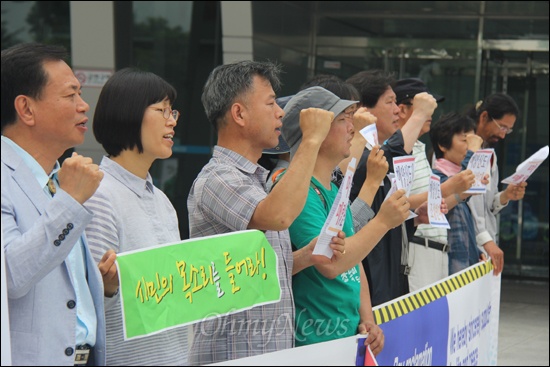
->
[347,70,437,306]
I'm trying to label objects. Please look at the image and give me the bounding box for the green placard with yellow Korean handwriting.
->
[117,230,281,339]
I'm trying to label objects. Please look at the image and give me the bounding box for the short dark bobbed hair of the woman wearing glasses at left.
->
[93,68,177,157]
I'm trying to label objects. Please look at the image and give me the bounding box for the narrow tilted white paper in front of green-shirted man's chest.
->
[313,158,357,259]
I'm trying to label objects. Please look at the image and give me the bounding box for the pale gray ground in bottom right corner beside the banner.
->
[498,279,550,366]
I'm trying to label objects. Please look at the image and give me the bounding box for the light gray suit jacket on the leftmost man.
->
[2,141,105,366]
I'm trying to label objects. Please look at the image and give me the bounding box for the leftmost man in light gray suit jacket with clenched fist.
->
[1,44,117,366]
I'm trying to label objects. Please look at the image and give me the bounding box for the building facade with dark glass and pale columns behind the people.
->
[2,1,549,279]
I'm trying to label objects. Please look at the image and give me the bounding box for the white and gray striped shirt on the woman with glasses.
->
[85,157,188,366]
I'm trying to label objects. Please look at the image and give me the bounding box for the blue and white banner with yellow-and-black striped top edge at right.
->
[373,262,501,366]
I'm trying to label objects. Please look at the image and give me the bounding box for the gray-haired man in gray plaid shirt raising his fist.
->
[187,60,347,364]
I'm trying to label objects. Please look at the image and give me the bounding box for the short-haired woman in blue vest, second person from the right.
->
[430,112,480,275]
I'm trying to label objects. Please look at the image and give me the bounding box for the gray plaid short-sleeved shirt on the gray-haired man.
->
[187,146,294,365]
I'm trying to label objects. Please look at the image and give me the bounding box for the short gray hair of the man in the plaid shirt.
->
[201,60,281,129]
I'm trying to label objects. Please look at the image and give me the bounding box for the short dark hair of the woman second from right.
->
[430,112,476,158]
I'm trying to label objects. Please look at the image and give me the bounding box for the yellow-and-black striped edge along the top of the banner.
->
[373,261,493,325]
